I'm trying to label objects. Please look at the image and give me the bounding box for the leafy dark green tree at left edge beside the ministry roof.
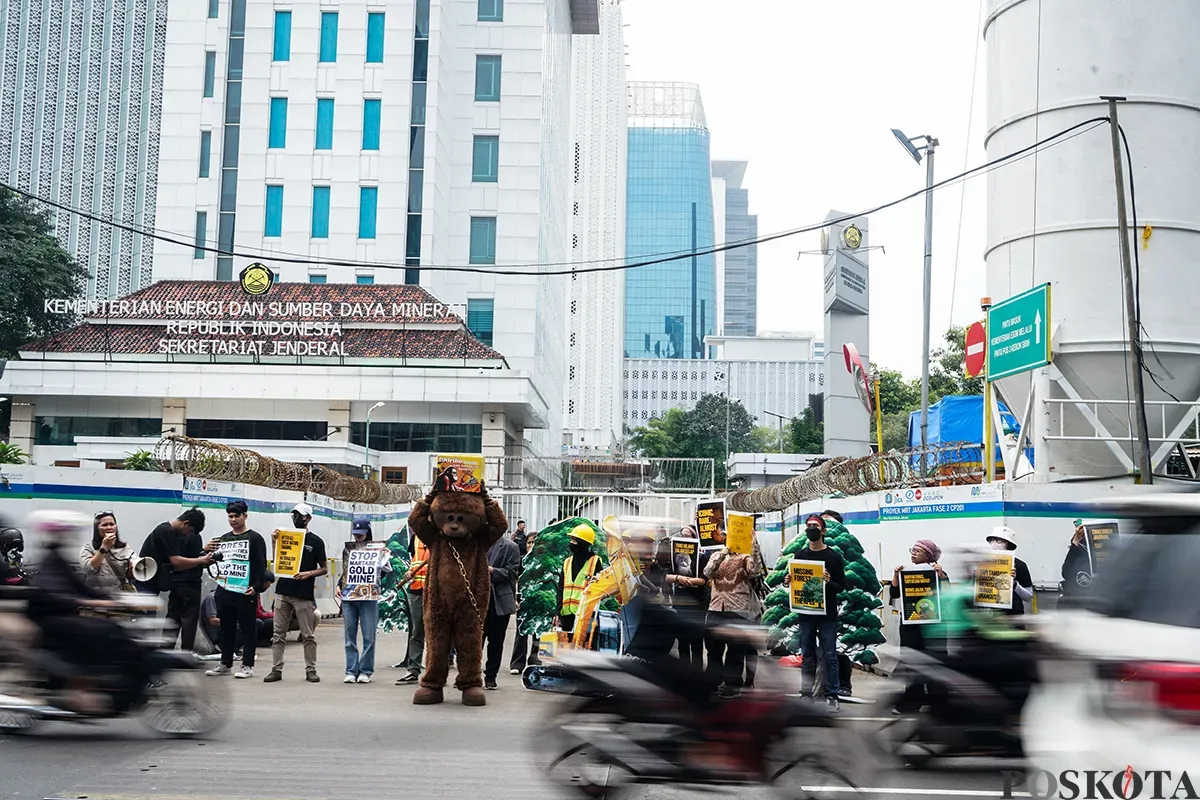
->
[0,188,88,357]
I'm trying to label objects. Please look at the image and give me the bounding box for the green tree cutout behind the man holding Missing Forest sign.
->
[762,519,886,664]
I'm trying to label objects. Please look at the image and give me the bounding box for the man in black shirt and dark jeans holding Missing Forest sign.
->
[797,513,846,711]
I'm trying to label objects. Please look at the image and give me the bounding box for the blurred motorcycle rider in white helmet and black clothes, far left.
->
[26,511,146,714]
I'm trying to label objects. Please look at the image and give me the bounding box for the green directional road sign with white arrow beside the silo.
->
[988,283,1051,380]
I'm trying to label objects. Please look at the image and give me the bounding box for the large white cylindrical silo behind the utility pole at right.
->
[984,0,1200,480]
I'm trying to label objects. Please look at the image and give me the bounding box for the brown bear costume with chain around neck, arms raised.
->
[408,487,509,705]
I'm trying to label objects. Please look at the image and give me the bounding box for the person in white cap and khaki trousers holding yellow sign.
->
[263,503,329,684]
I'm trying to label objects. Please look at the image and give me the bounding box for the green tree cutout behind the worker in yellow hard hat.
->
[517,517,617,637]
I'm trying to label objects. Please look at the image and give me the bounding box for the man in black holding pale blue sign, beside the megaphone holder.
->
[204,500,266,679]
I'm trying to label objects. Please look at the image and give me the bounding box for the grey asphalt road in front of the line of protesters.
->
[0,625,1022,800]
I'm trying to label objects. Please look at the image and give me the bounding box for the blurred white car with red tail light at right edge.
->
[1021,494,1200,777]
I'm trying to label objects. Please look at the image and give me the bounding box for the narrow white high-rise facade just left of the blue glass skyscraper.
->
[563,0,628,453]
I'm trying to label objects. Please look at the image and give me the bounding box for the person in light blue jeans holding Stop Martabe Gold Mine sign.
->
[338,517,391,684]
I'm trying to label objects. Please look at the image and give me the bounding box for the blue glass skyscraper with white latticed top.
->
[625,83,718,359]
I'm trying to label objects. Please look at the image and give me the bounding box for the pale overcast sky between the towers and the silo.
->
[623,0,986,377]
